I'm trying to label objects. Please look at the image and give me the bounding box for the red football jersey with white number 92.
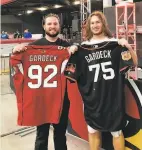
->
[10,45,69,126]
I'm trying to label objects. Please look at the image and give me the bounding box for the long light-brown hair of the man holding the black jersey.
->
[86,11,113,40]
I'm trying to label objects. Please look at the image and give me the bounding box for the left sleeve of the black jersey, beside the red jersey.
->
[64,52,80,81]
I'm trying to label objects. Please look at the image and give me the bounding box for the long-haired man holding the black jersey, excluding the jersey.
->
[84,11,137,150]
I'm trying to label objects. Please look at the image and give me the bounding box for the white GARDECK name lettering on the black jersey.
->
[85,50,111,63]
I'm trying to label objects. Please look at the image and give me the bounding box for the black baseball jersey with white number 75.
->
[65,41,132,131]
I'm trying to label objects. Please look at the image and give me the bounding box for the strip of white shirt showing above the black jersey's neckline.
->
[81,38,118,45]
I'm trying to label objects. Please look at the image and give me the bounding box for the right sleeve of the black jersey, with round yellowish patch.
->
[119,48,134,73]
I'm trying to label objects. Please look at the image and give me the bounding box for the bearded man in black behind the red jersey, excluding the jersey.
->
[13,14,76,150]
